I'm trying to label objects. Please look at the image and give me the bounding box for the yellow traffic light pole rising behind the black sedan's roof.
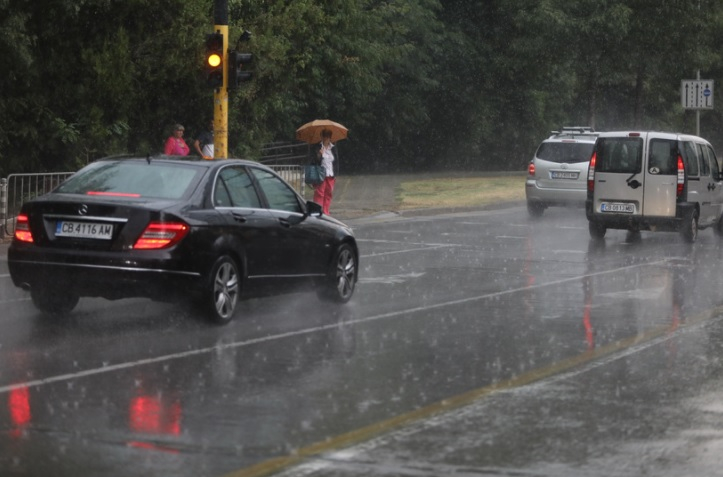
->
[213,0,228,159]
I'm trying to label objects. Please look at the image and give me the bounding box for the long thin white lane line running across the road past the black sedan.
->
[0,259,667,394]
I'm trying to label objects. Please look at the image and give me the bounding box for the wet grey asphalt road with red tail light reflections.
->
[0,207,723,477]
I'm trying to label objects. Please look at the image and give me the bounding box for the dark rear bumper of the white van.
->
[585,199,696,232]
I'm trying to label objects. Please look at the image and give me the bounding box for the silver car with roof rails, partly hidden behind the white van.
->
[525,128,597,217]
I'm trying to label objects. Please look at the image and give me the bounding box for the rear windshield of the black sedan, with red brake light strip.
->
[56,161,203,199]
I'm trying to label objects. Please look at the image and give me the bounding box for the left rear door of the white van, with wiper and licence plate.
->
[593,133,647,216]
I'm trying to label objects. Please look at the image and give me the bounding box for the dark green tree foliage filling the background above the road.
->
[0,0,723,176]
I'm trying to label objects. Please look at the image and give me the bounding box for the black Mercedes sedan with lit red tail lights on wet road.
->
[8,157,359,323]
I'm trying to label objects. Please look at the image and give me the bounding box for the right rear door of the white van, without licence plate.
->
[643,137,678,217]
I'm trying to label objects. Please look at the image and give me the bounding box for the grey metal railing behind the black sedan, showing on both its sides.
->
[0,165,306,238]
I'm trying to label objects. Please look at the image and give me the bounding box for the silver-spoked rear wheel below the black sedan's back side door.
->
[202,255,241,324]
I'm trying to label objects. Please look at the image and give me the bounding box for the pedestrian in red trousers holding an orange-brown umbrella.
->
[296,119,348,215]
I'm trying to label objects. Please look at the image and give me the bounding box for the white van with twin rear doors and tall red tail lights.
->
[585,131,723,243]
